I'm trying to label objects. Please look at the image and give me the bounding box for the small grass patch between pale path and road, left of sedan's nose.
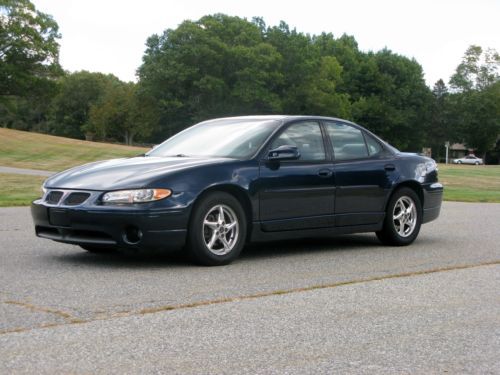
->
[0,173,46,207]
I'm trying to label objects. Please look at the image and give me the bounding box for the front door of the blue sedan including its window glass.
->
[259,121,335,232]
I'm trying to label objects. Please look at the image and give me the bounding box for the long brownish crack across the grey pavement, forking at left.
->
[0,260,500,335]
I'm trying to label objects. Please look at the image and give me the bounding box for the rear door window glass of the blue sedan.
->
[325,122,370,160]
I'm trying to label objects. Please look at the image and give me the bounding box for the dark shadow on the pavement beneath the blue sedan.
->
[47,234,382,269]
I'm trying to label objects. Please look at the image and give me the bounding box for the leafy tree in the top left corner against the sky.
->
[0,0,61,101]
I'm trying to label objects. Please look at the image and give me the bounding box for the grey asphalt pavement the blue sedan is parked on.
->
[0,203,500,374]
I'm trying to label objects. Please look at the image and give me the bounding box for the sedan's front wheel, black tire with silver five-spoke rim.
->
[187,192,247,266]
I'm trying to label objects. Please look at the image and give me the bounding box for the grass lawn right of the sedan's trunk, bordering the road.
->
[439,164,500,203]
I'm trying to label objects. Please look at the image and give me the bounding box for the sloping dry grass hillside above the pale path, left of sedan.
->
[0,128,147,172]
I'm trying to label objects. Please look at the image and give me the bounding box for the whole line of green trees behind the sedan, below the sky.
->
[0,0,500,162]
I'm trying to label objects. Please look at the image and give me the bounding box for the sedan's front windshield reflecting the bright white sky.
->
[146,118,280,159]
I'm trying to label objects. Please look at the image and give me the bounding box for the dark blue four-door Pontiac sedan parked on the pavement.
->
[32,116,443,265]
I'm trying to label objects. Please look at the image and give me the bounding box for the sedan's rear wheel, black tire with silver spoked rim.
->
[376,187,422,246]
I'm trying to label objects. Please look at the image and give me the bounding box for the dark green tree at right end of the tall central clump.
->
[352,49,432,151]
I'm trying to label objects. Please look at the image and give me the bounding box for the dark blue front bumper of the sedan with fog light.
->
[31,200,188,249]
